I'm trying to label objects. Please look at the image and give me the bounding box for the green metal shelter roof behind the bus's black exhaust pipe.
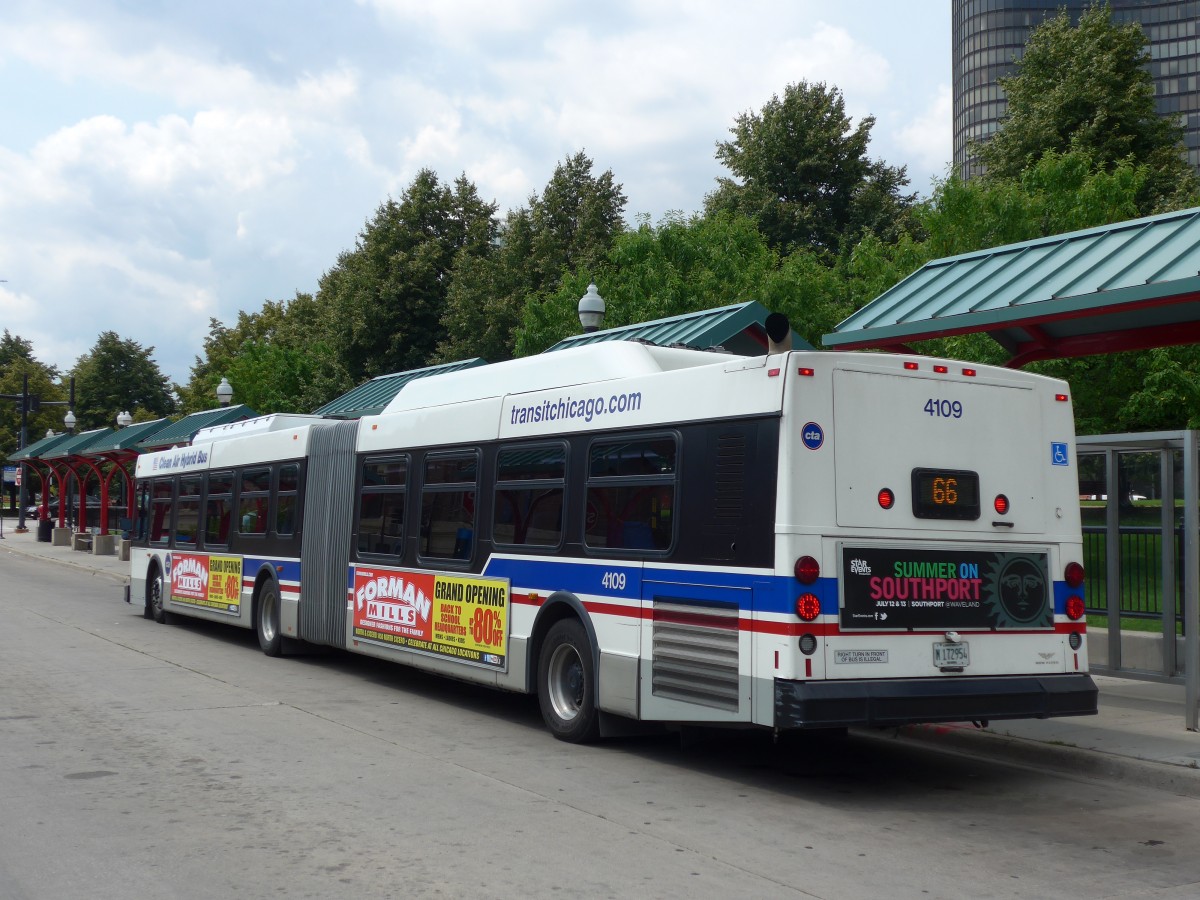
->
[546,300,814,356]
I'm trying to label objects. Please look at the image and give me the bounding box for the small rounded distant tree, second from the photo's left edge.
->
[71,331,175,431]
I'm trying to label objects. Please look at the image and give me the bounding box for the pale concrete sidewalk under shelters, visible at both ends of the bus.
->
[0,520,1200,798]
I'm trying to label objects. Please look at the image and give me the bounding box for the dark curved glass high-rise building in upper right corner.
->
[952,0,1200,178]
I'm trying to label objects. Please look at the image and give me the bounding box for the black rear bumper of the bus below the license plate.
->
[775,673,1097,728]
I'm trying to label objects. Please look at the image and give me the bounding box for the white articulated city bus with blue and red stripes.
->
[132,342,1096,742]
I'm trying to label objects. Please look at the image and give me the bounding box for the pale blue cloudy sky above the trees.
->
[0,0,952,402]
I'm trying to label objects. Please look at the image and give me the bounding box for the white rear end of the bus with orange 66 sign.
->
[757,354,1097,728]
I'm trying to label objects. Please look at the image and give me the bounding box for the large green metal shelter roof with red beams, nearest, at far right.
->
[823,209,1200,367]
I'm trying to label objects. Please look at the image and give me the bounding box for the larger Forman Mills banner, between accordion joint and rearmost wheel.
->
[352,566,509,668]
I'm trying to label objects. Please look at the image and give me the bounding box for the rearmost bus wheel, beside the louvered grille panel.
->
[538,619,600,744]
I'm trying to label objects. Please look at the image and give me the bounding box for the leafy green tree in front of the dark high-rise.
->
[974,5,1196,215]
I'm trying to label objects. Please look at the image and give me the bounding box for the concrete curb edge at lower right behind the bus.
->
[858,724,1200,799]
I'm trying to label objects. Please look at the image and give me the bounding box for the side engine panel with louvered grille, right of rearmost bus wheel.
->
[641,578,751,722]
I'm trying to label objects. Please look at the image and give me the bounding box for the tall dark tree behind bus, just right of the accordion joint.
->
[317,169,496,382]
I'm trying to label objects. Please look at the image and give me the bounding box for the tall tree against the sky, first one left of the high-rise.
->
[704,82,914,253]
